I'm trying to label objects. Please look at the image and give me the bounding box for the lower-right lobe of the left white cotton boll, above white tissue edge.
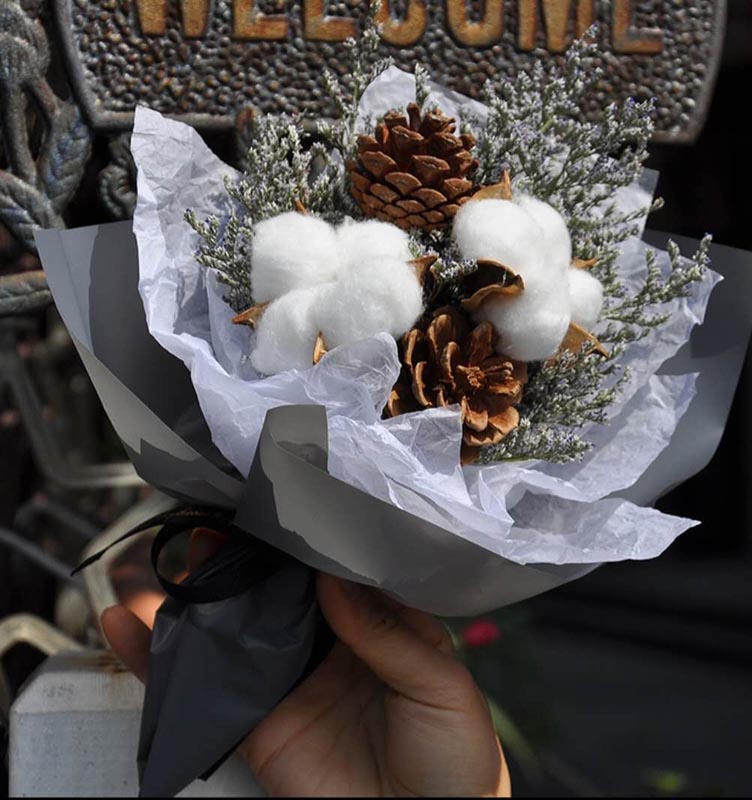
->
[317,258,423,348]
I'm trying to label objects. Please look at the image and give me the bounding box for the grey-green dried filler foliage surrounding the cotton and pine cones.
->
[187,23,710,463]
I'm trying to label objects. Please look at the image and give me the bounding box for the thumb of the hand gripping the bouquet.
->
[318,573,472,707]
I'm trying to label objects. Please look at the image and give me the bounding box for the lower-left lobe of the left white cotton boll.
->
[251,284,328,375]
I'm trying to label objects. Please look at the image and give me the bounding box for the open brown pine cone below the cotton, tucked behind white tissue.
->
[385,306,527,463]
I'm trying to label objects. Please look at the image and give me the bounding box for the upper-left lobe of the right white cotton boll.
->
[452,200,546,280]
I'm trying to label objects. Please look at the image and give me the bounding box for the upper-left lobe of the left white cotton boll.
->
[251,211,340,303]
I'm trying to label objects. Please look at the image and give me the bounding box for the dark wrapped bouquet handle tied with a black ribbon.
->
[75,506,335,797]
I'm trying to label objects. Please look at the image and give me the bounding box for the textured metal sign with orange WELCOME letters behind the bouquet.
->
[52,0,725,139]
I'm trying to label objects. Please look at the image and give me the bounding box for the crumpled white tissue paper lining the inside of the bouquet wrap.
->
[132,69,719,564]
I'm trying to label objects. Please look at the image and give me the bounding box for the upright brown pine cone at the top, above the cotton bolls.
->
[348,103,478,231]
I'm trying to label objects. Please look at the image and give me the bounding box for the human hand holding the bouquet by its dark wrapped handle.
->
[102,536,510,797]
